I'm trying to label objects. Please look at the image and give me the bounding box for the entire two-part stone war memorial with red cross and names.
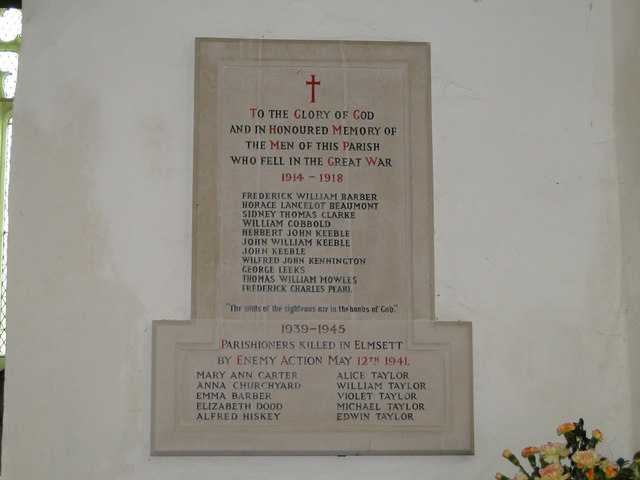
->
[152,39,473,455]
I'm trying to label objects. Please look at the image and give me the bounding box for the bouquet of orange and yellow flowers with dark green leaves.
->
[496,419,640,480]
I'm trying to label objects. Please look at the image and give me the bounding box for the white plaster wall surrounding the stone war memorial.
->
[2,0,639,480]
